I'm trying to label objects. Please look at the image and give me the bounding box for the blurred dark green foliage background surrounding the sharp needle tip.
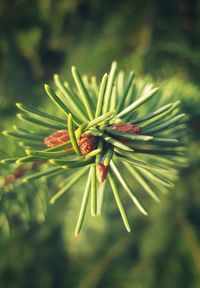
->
[0,0,200,288]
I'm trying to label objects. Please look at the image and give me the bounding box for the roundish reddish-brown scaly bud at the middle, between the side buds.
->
[79,133,97,155]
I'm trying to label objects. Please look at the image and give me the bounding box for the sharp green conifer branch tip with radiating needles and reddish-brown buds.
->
[1,62,185,235]
